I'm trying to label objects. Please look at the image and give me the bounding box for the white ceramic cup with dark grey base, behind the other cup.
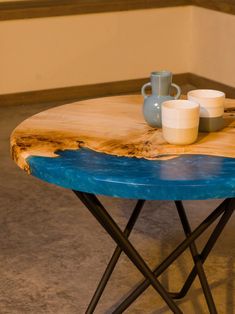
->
[187,89,225,132]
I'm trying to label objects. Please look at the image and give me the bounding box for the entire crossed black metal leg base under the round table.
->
[74,191,235,314]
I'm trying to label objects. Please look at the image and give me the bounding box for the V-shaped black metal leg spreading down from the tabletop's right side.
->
[113,198,235,314]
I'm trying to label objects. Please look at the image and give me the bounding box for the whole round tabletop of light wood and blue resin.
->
[11,95,235,199]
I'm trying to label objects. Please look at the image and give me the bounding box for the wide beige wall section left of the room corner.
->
[0,7,191,94]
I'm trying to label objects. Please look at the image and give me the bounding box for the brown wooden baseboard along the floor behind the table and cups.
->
[0,73,235,106]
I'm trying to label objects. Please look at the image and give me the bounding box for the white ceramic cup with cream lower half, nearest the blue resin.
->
[162,100,200,145]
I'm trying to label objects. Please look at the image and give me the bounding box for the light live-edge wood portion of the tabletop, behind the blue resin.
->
[11,95,235,173]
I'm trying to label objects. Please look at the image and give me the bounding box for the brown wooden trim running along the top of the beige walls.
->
[0,0,235,21]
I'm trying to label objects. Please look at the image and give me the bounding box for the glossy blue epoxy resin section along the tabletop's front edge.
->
[27,148,235,200]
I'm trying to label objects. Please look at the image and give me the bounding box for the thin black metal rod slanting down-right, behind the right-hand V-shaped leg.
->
[175,201,217,314]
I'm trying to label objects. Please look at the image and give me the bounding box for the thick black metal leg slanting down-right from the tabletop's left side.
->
[74,191,183,314]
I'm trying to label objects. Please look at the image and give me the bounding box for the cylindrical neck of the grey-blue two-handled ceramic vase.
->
[151,71,172,96]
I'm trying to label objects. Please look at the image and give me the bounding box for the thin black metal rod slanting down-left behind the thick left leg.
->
[86,200,145,314]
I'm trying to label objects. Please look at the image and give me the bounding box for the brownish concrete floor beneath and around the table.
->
[0,94,235,314]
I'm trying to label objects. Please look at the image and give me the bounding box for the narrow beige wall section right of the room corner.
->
[191,7,235,87]
